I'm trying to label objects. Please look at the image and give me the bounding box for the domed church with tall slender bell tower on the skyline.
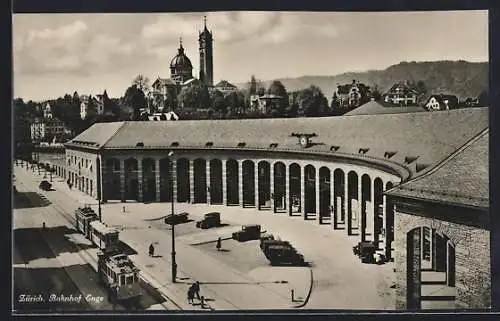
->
[151,17,218,110]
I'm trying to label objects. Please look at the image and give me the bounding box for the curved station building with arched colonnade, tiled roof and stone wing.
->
[58,108,491,309]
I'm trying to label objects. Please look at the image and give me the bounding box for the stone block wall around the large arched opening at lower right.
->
[394,206,491,309]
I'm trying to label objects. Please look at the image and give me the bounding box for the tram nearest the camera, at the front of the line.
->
[97,251,142,301]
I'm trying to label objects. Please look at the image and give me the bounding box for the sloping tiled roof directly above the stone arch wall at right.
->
[386,130,489,208]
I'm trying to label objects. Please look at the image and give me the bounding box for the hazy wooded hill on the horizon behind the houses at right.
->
[238,60,488,99]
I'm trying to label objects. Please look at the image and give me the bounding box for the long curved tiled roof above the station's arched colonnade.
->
[67,108,488,177]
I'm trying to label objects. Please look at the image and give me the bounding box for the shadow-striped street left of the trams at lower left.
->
[13,169,165,312]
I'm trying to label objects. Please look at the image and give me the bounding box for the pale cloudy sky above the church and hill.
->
[12,11,488,101]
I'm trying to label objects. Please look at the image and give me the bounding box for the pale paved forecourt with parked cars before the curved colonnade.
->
[16,162,394,309]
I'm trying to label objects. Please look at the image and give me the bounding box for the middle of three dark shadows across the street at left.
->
[13,222,93,264]
